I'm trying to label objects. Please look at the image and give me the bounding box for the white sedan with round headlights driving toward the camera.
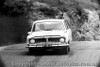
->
[26,19,72,53]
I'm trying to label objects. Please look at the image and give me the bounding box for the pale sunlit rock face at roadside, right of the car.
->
[73,9,100,41]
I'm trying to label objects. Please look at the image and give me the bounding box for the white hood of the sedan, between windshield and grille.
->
[27,30,67,39]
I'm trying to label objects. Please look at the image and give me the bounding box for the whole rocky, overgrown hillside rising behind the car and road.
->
[0,0,100,44]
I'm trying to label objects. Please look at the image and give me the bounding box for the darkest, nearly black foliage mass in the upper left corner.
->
[0,0,28,17]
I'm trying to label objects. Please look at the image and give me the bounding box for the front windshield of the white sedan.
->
[33,21,65,31]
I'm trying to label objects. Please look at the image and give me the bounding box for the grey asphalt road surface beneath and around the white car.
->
[0,41,100,67]
